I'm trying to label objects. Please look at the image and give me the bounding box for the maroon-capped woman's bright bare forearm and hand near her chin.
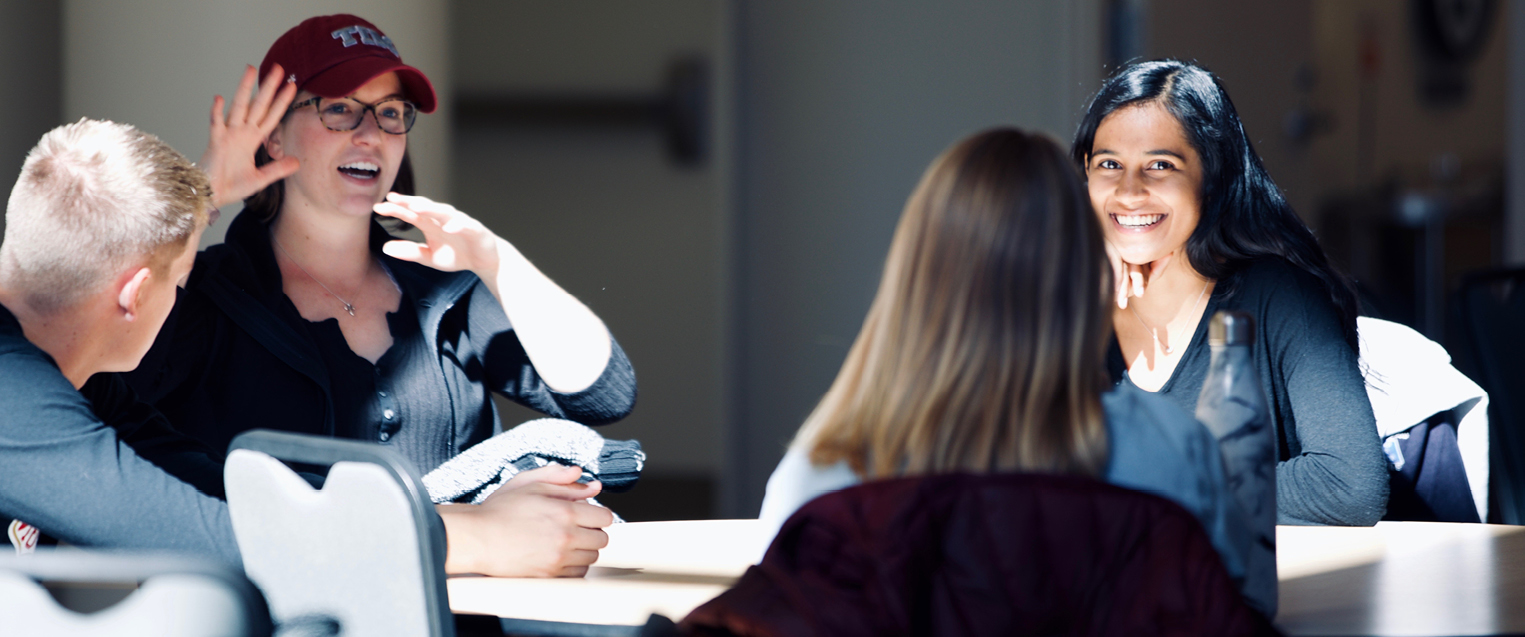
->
[375,192,613,393]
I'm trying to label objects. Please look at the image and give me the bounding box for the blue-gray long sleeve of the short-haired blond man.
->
[0,352,242,568]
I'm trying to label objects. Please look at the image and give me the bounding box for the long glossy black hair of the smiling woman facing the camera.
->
[1071,59,1360,351]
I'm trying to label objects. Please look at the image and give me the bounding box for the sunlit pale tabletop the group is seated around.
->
[447,520,1525,635]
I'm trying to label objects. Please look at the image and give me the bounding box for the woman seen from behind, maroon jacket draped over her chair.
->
[738,128,1263,634]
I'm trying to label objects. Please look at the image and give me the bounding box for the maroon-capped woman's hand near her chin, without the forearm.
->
[375,192,499,279]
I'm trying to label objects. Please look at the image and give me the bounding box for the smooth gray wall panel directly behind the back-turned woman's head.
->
[721,0,1101,515]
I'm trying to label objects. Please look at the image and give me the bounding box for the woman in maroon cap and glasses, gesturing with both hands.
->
[131,15,636,575]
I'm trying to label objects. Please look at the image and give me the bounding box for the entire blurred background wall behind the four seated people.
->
[0,0,1525,520]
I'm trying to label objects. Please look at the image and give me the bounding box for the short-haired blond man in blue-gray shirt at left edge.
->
[0,116,610,575]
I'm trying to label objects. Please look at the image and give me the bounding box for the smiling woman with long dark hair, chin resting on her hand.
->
[1071,59,1388,524]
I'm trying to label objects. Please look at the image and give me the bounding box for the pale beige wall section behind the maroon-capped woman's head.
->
[63,0,451,245]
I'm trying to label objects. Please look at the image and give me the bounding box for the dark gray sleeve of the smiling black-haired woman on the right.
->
[1264,275,1389,526]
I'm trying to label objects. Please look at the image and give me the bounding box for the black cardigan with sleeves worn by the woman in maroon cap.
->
[127,208,636,492]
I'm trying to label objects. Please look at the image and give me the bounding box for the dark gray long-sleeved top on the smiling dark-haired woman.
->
[1107,258,1388,526]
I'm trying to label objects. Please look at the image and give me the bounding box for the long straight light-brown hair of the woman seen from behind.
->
[795,128,1112,479]
